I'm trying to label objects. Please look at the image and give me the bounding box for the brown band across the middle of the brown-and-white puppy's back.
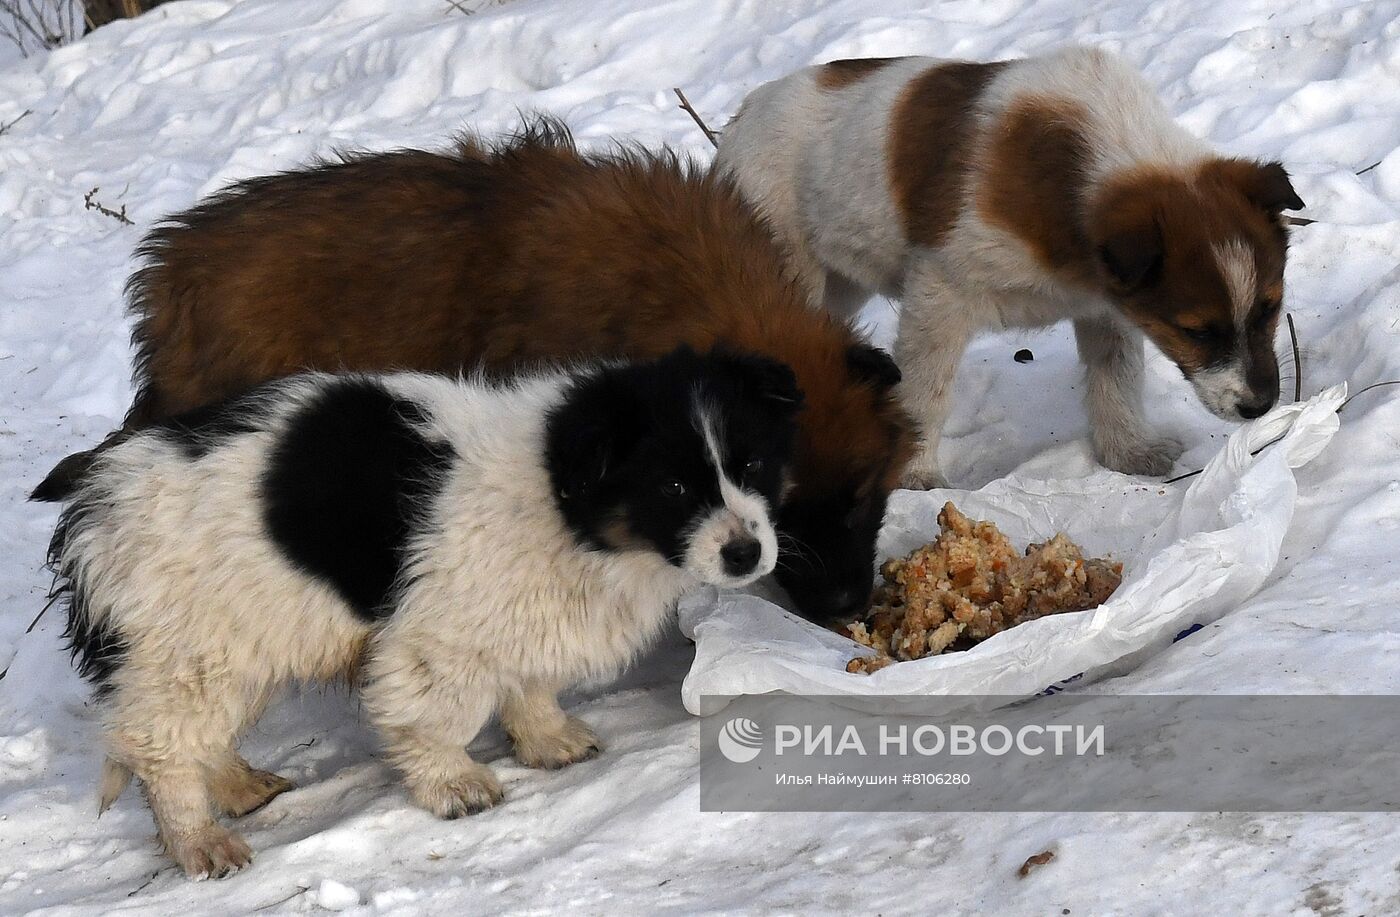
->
[889,62,1005,246]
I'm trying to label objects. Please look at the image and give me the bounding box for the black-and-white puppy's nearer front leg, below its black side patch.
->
[363,633,504,819]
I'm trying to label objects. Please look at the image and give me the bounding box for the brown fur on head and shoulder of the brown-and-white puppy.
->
[977,98,1302,374]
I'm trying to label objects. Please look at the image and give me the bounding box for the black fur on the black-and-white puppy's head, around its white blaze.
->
[545,347,802,564]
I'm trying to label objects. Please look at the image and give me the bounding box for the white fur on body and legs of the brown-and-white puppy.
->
[715,48,1211,487]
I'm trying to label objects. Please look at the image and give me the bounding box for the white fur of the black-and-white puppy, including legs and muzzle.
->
[59,372,776,875]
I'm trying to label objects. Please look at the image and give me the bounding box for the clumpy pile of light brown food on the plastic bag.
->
[846,503,1123,675]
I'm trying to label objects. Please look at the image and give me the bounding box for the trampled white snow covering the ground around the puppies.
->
[0,0,1400,917]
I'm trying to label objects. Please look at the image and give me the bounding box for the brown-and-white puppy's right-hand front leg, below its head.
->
[1074,318,1182,477]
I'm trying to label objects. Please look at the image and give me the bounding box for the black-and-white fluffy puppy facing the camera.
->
[35,349,802,876]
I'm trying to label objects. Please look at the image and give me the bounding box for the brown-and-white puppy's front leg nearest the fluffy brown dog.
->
[895,259,979,490]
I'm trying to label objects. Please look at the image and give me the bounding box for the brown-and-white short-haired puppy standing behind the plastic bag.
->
[717,48,1303,487]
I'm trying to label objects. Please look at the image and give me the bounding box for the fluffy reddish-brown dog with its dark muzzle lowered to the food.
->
[109,120,913,620]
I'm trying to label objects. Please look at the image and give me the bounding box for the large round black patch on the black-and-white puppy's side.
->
[262,378,452,622]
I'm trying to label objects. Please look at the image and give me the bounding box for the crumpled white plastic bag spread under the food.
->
[680,385,1347,715]
